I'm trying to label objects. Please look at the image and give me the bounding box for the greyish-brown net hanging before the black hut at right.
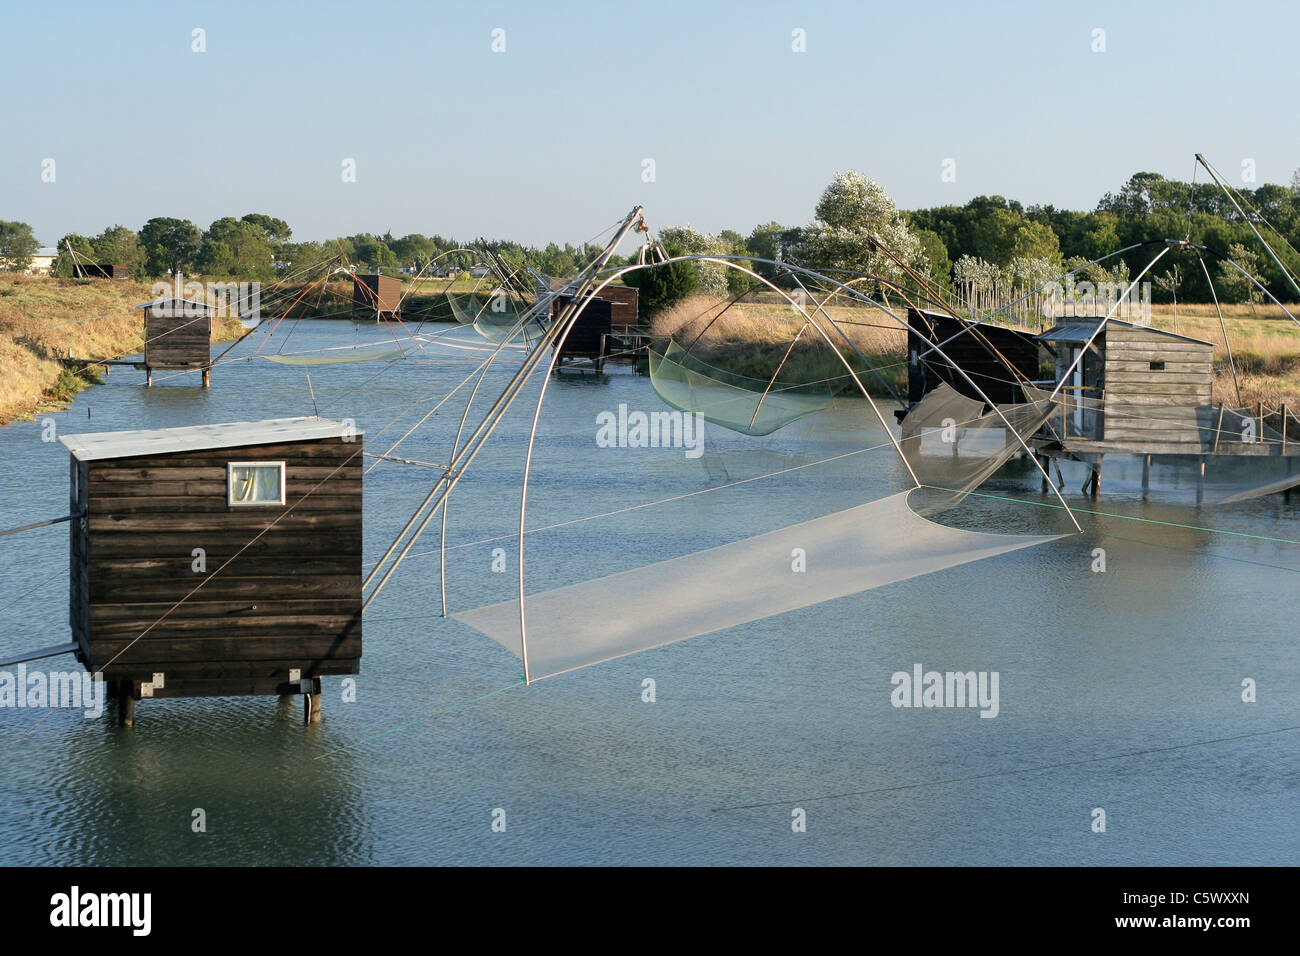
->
[898,384,1056,514]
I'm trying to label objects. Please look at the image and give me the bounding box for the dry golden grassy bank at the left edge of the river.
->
[0,273,243,424]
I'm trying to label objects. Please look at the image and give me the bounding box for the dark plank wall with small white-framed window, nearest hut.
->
[87,437,363,696]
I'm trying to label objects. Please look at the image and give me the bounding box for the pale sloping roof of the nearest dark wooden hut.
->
[60,418,361,462]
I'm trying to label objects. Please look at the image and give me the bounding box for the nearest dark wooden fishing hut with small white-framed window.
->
[61,418,363,723]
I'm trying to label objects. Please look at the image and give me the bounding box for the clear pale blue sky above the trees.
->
[0,0,1300,245]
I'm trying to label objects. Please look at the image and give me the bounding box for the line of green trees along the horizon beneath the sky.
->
[0,167,1300,302]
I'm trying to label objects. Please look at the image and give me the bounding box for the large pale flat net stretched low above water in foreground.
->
[452,492,1061,679]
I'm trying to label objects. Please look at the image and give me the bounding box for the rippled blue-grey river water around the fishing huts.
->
[0,321,1300,865]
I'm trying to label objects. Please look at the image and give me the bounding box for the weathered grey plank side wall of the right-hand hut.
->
[1105,324,1214,445]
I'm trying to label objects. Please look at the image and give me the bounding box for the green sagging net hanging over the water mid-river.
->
[647,338,832,436]
